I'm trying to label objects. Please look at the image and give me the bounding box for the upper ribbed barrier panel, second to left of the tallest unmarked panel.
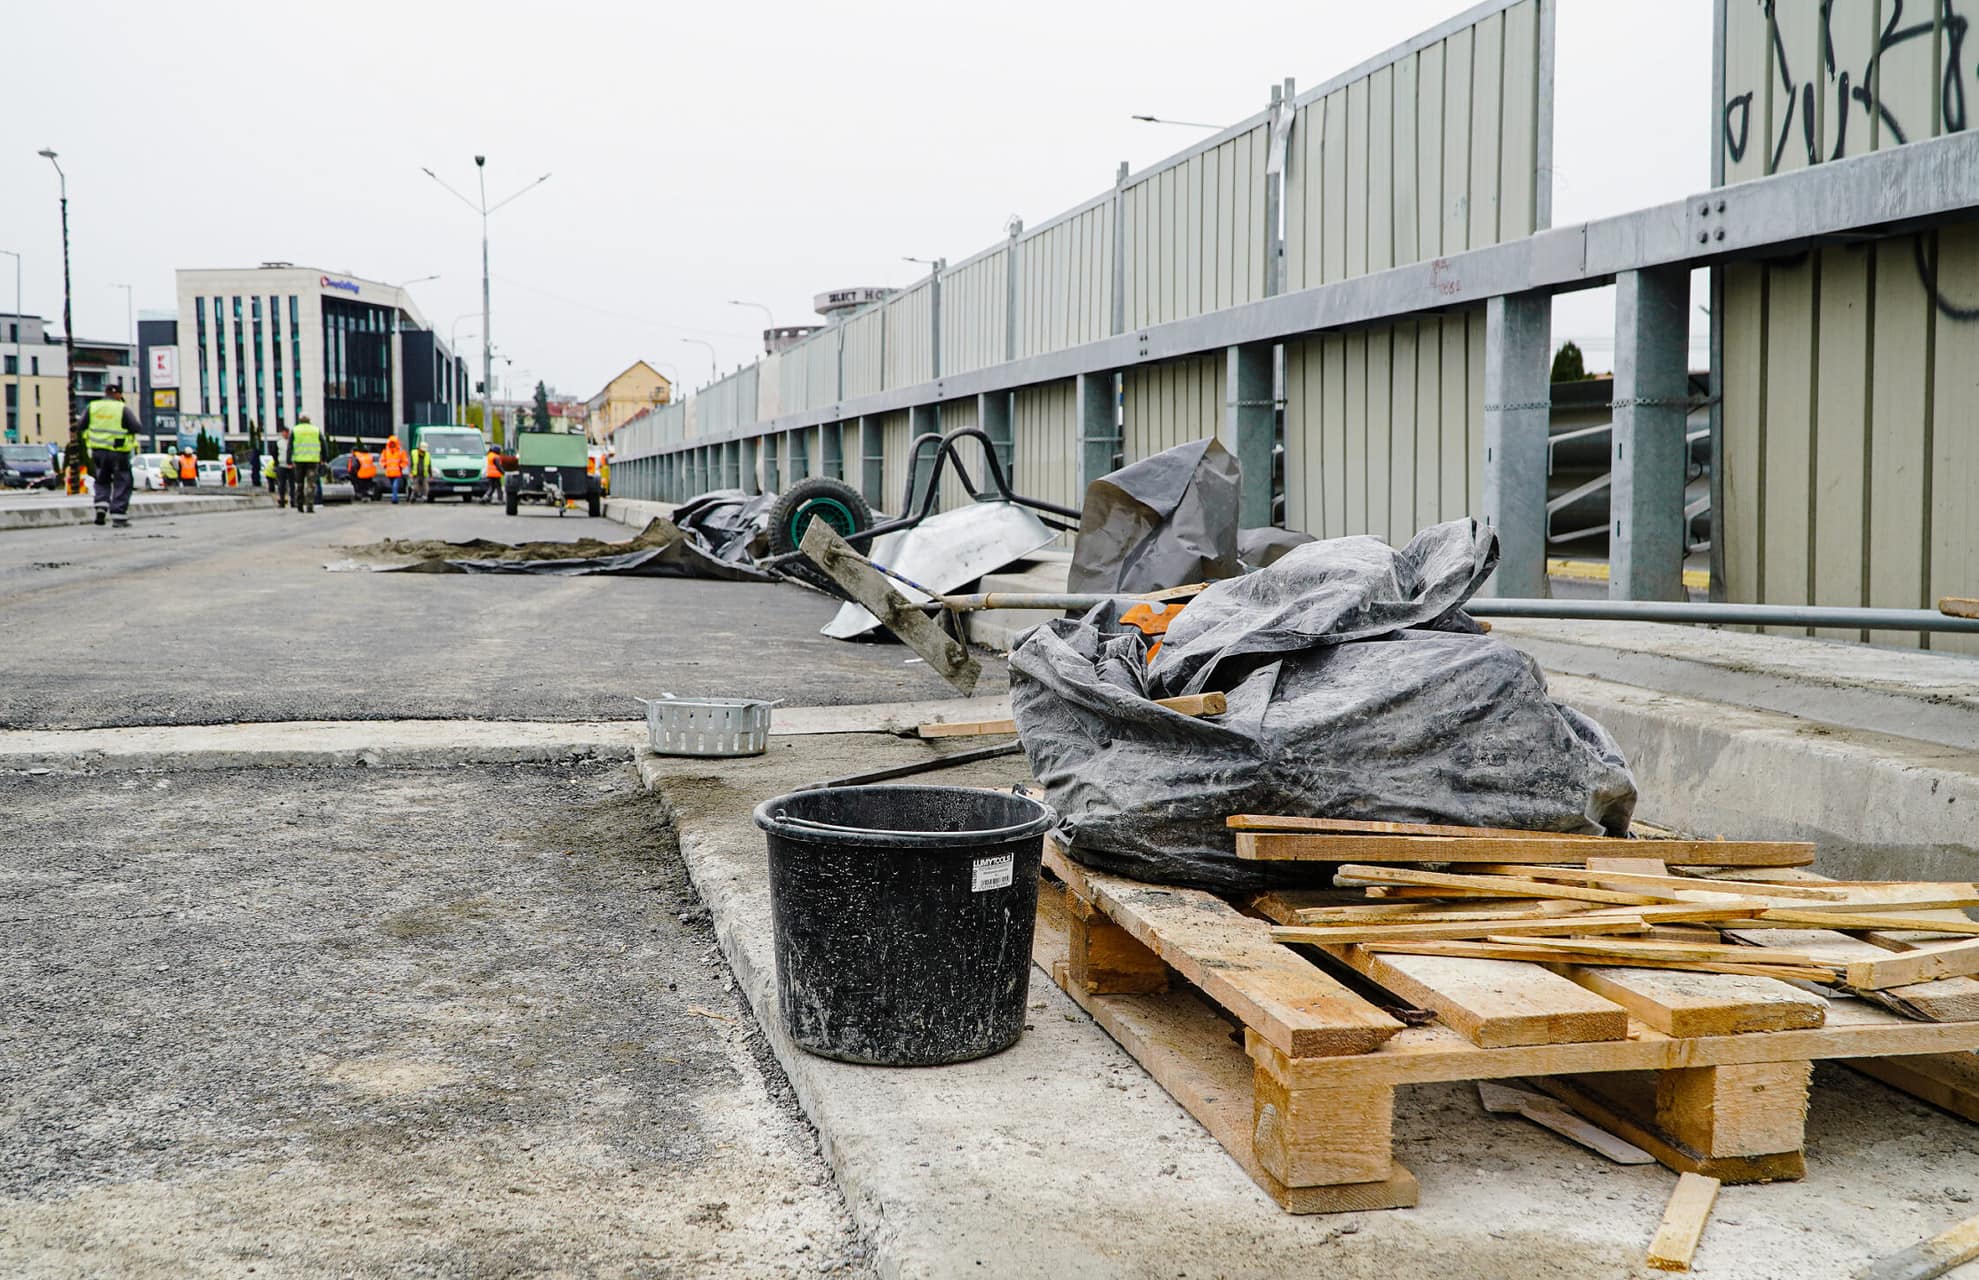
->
[1015,194,1114,358]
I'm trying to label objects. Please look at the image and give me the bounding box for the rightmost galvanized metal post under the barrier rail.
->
[1609,267,1690,599]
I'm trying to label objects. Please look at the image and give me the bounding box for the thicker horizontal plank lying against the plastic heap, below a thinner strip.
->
[1237,831,1815,867]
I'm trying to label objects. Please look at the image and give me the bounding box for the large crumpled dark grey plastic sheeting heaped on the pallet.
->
[1009,520,1635,892]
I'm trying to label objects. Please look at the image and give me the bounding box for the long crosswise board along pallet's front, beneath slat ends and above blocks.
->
[1247,1001,1979,1092]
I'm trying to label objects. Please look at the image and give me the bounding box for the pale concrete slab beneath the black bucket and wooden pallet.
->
[639,736,1979,1280]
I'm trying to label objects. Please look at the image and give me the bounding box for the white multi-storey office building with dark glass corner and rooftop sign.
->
[169,263,469,443]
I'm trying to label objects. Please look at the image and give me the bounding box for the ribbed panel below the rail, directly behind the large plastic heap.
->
[1284,309,1484,546]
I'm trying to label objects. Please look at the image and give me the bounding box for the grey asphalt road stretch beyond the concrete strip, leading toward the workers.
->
[0,503,1007,728]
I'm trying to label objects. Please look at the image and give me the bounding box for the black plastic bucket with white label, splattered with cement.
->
[756,787,1057,1066]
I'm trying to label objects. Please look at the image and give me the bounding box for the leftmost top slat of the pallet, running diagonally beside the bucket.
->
[1045,841,1401,1058]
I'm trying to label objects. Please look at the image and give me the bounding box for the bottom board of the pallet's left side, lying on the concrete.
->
[1037,910,1417,1213]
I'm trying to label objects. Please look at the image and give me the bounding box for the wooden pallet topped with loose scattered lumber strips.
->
[1035,815,1979,1213]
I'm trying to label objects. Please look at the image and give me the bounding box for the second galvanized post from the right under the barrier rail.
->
[1484,293,1554,597]
